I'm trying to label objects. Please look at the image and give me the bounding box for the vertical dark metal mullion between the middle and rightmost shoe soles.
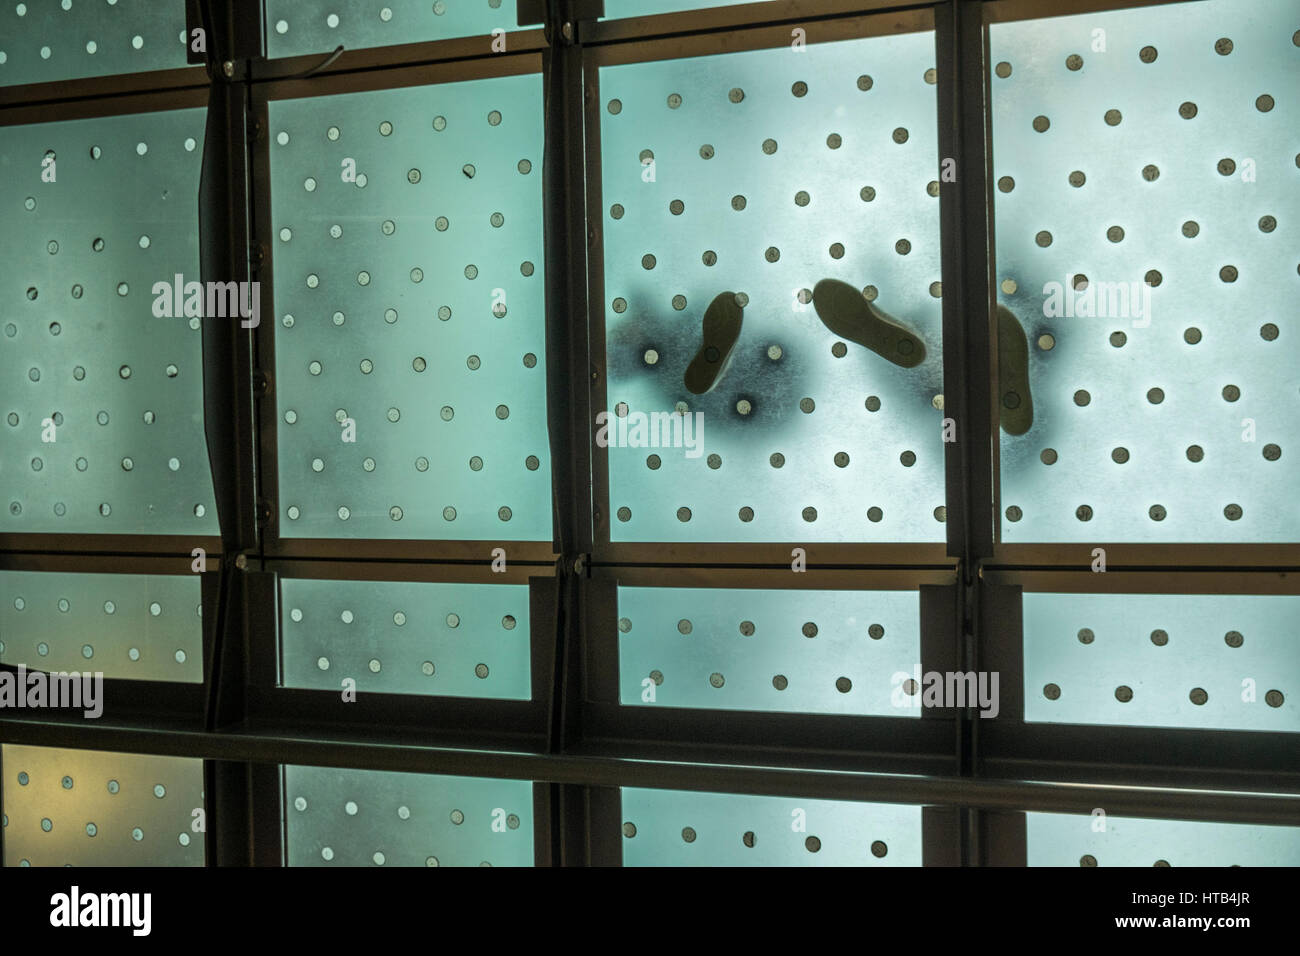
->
[935,0,995,865]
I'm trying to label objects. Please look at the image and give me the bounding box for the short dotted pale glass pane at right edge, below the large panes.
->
[1023,592,1300,732]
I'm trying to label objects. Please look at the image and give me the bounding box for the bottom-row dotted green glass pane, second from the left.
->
[283,766,534,866]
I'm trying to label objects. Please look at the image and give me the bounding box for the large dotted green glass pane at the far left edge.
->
[0,107,219,535]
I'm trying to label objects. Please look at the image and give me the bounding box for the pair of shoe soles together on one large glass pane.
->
[685,278,926,395]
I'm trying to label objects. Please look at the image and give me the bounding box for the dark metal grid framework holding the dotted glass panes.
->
[0,0,1300,866]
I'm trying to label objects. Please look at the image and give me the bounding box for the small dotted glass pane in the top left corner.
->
[0,0,189,87]
